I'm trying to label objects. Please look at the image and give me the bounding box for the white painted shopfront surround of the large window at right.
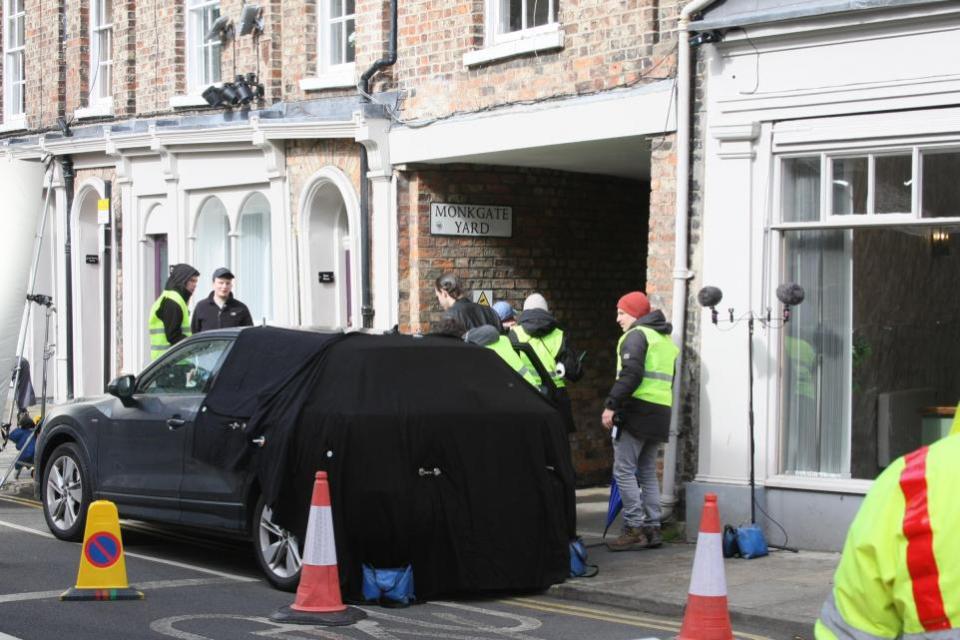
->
[697,3,960,493]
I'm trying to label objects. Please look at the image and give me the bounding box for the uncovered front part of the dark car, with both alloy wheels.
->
[36,329,300,590]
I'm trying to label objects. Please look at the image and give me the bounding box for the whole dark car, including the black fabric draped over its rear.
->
[37,327,576,600]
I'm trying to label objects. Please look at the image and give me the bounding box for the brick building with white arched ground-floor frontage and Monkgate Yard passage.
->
[0,0,685,492]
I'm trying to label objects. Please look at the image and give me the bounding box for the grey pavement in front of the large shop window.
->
[564,487,840,640]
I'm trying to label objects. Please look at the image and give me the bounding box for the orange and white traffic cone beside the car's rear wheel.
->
[270,471,367,626]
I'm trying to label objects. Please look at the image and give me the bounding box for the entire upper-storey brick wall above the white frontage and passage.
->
[0,0,680,128]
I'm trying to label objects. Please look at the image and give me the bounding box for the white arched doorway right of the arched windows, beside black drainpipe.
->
[300,167,360,329]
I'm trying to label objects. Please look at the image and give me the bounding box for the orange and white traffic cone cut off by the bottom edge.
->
[677,493,733,640]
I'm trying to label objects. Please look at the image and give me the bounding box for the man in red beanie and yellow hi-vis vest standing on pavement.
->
[600,291,680,551]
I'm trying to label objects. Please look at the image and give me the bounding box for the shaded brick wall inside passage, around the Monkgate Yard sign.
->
[398,165,649,482]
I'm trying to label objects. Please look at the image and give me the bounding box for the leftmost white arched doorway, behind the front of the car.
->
[72,186,106,397]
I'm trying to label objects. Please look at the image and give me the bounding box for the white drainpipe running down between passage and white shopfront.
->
[660,0,714,518]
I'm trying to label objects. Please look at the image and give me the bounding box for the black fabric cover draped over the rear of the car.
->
[196,328,576,600]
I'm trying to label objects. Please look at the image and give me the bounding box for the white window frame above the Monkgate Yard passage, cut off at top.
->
[463,0,564,67]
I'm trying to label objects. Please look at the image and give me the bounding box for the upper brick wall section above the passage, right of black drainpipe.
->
[381,0,679,118]
